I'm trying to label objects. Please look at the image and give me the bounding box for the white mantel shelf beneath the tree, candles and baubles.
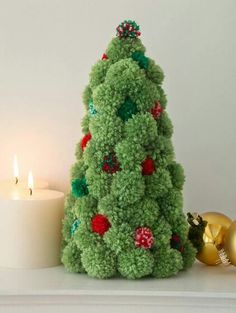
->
[0,263,236,313]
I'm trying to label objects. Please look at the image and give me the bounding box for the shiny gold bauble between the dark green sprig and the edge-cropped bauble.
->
[197,212,232,265]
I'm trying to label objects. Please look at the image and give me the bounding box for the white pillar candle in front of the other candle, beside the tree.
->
[0,190,64,268]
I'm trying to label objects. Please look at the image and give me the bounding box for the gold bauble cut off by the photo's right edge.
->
[224,221,236,266]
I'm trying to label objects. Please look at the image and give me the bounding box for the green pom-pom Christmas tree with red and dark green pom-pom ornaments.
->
[62,21,196,279]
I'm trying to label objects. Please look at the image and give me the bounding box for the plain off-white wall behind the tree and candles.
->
[0,0,236,218]
